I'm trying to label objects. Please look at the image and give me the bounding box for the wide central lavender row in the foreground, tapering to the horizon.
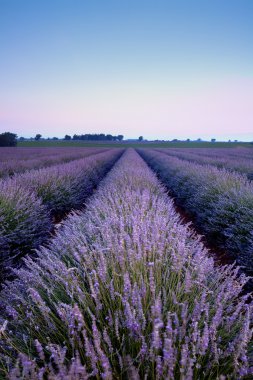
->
[0,150,253,380]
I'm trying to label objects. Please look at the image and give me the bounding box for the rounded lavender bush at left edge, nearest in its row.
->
[0,180,52,275]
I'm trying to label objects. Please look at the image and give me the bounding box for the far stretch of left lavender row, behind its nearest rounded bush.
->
[11,149,123,217]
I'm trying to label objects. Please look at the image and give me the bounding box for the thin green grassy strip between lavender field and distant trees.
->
[18,140,253,148]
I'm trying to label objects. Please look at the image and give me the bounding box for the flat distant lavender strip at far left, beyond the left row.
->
[0,148,108,178]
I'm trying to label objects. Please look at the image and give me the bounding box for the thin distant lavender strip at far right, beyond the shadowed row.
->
[155,148,253,180]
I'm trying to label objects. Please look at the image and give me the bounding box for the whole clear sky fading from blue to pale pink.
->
[0,0,253,141]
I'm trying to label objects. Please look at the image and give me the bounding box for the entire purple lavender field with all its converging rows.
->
[0,148,253,380]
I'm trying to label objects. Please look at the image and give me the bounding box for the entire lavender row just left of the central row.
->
[0,150,123,276]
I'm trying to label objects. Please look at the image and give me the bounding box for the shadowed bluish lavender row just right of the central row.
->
[138,149,253,273]
